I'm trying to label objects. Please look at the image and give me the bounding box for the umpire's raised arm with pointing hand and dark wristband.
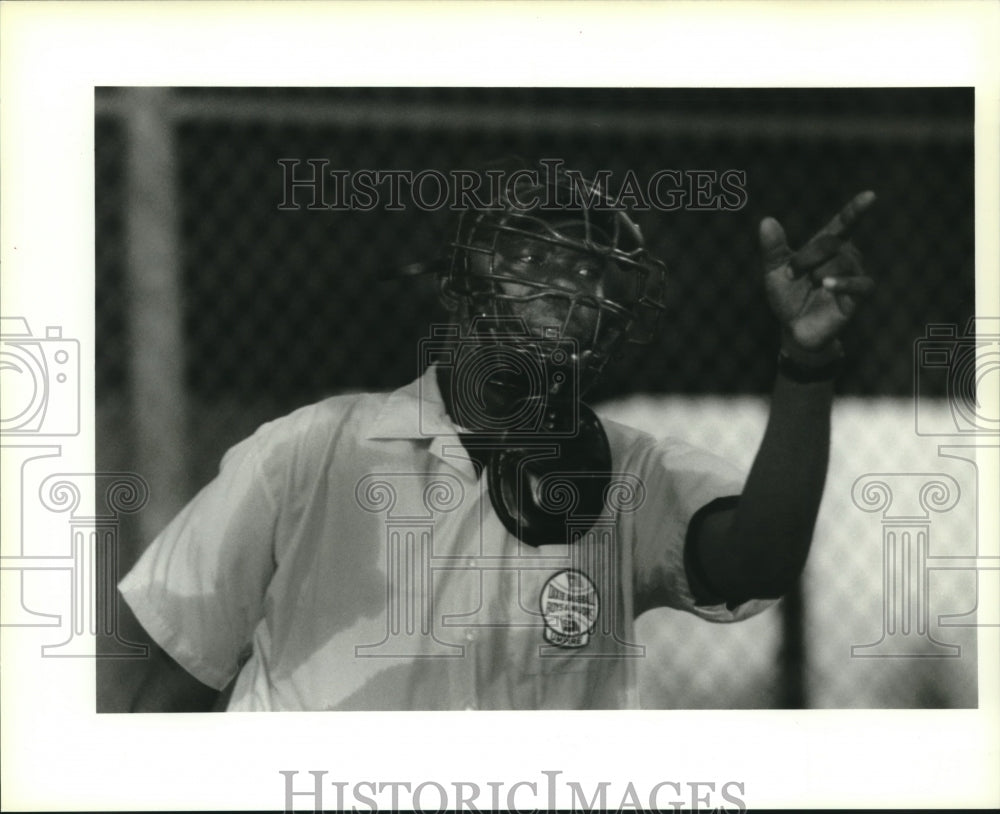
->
[688,192,875,604]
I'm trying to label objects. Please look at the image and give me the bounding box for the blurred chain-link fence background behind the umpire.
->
[94,88,995,711]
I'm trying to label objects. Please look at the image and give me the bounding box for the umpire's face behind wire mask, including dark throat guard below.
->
[447,230,626,546]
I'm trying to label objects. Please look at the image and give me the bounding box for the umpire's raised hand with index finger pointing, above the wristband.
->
[760,192,875,358]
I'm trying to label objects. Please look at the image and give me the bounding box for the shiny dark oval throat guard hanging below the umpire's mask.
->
[486,402,611,547]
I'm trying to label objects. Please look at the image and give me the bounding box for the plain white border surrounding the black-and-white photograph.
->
[0,2,1000,811]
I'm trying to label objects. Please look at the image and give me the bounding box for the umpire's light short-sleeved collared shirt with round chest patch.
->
[119,369,771,710]
